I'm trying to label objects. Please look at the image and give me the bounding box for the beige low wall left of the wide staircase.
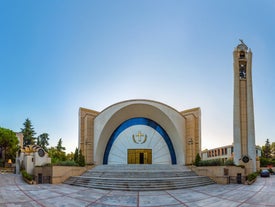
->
[34,166,93,184]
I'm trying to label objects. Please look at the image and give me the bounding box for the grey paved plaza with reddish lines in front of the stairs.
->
[0,174,275,207]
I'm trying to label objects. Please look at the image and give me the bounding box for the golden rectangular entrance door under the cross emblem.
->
[128,149,152,164]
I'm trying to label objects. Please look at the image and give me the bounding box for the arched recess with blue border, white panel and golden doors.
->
[103,117,177,164]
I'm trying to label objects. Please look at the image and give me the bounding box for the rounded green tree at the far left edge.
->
[0,127,19,161]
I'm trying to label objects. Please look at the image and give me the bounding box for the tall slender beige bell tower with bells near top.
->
[233,40,256,173]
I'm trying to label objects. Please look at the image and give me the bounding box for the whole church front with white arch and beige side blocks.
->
[79,100,201,165]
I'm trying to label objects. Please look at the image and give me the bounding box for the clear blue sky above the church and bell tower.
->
[0,0,275,152]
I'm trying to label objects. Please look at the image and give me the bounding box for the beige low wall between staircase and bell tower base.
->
[192,166,246,184]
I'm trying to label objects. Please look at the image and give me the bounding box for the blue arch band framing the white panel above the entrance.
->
[103,117,177,165]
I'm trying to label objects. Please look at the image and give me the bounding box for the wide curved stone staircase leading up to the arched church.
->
[65,164,215,191]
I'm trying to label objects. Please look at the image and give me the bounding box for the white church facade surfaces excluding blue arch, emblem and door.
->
[94,100,185,164]
